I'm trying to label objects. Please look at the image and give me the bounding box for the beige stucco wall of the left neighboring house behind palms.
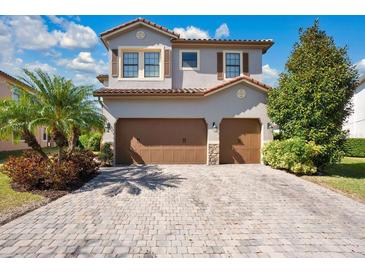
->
[0,77,47,151]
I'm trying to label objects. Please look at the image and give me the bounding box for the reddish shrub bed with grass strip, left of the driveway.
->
[0,151,99,225]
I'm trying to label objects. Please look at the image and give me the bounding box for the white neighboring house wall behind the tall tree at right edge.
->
[344,82,365,138]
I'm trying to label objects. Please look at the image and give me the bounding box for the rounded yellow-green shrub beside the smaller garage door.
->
[263,138,321,174]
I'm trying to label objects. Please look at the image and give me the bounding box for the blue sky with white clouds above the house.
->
[0,15,365,85]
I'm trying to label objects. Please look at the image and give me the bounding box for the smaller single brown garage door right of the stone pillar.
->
[219,118,261,164]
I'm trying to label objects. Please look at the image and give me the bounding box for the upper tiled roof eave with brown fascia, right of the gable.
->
[171,38,274,53]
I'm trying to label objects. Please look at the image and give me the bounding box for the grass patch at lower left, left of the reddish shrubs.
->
[0,168,44,215]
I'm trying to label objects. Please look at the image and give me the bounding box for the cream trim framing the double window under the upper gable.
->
[118,46,165,81]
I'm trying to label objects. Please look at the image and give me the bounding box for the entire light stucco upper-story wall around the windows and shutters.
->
[107,26,262,89]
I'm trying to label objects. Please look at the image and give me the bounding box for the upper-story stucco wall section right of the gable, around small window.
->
[172,48,262,88]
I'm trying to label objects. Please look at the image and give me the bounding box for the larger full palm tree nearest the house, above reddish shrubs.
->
[23,69,104,161]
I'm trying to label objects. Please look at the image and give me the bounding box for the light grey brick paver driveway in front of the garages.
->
[0,165,365,257]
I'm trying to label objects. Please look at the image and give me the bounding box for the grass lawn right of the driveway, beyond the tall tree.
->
[303,157,365,202]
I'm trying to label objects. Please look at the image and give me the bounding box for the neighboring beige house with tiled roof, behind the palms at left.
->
[0,70,51,151]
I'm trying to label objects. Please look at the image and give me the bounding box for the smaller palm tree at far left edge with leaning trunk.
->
[0,87,48,160]
